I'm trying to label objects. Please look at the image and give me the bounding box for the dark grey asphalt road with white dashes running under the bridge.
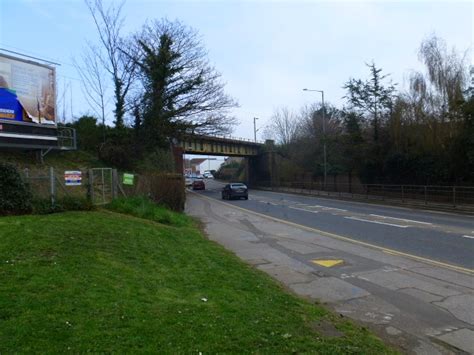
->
[192,180,474,269]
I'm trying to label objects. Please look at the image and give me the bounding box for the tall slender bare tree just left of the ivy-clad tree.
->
[85,0,135,128]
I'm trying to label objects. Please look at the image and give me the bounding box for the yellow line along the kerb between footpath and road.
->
[189,191,474,275]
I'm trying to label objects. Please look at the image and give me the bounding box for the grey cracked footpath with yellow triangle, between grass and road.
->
[186,192,474,354]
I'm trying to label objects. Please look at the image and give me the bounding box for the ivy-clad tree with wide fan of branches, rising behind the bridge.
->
[134,20,236,146]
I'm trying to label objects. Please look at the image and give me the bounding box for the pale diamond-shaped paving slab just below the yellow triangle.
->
[289,277,369,303]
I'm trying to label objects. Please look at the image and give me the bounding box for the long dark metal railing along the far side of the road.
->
[258,181,474,210]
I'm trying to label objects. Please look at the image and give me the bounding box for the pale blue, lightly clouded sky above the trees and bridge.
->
[0,0,474,153]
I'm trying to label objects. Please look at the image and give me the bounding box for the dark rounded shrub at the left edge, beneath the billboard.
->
[0,163,32,215]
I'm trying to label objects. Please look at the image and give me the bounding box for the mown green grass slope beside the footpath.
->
[0,203,391,354]
